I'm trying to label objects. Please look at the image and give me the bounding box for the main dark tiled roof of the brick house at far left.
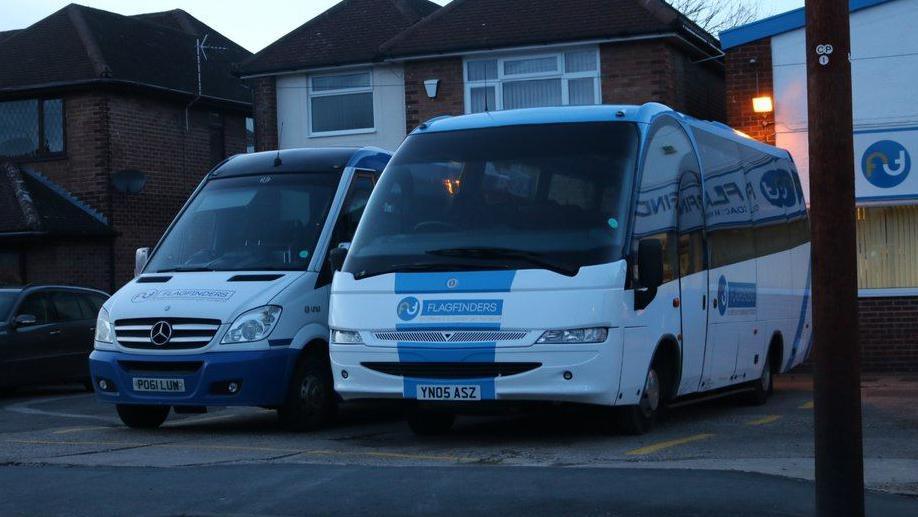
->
[0,4,252,104]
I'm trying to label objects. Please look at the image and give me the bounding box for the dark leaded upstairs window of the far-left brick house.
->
[0,99,64,159]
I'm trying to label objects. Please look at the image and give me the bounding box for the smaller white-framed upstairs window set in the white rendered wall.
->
[309,71,374,136]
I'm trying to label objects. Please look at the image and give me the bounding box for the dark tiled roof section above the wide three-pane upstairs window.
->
[381,0,717,57]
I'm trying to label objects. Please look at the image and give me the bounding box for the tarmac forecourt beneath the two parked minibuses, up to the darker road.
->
[0,375,918,514]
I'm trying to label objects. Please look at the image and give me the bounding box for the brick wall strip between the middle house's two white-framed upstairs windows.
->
[405,58,465,133]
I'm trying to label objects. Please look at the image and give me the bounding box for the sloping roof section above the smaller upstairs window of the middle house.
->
[240,0,440,75]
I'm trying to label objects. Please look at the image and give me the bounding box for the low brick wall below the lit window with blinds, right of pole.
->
[858,297,918,372]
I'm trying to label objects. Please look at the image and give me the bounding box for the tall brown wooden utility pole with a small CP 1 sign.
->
[806,0,864,517]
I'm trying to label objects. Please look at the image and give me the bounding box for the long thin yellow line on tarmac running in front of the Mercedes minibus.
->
[6,440,478,463]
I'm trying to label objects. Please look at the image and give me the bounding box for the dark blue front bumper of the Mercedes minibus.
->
[89,348,299,407]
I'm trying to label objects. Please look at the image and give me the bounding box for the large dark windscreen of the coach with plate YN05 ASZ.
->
[344,122,639,278]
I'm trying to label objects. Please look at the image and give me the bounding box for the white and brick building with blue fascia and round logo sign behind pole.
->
[721,0,918,371]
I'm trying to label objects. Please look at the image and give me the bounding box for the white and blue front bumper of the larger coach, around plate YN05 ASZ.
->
[331,329,622,406]
